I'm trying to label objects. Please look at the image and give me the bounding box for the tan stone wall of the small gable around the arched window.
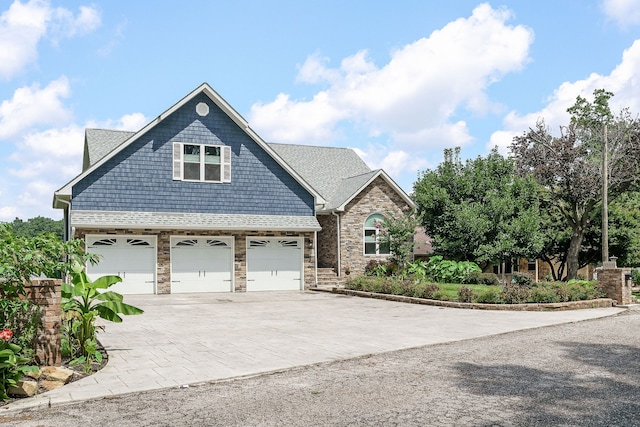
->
[340,177,407,274]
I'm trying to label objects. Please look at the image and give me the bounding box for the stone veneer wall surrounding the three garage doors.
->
[74,228,316,294]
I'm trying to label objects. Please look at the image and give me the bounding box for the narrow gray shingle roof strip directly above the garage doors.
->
[71,210,321,232]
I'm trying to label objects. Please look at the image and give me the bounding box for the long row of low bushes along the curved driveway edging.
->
[345,275,604,304]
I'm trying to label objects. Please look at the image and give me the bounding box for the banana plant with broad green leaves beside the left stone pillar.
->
[62,263,143,370]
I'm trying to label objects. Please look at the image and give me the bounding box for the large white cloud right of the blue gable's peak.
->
[250,4,533,149]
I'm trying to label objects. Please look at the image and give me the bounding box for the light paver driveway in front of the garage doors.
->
[6,292,622,410]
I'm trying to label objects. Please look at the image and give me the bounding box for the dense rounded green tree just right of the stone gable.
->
[414,148,542,263]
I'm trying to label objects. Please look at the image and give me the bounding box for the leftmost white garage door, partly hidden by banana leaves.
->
[87,236,156,294]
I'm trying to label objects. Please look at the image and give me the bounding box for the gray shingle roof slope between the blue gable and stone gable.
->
[269,143,371,207]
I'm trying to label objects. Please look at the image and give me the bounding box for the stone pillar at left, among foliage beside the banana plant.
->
[25,279,62,366]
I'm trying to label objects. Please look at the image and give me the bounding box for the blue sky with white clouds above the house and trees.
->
[0,0,640,221]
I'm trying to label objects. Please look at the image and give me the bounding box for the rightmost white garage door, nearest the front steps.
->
[247,238,303,291]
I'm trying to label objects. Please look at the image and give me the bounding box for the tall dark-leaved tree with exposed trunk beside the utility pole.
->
[511,89,640,279]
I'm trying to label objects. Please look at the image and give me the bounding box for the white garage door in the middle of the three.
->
[171,237,233,294]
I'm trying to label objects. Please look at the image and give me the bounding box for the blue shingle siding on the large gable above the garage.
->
[72,94,314,219]
